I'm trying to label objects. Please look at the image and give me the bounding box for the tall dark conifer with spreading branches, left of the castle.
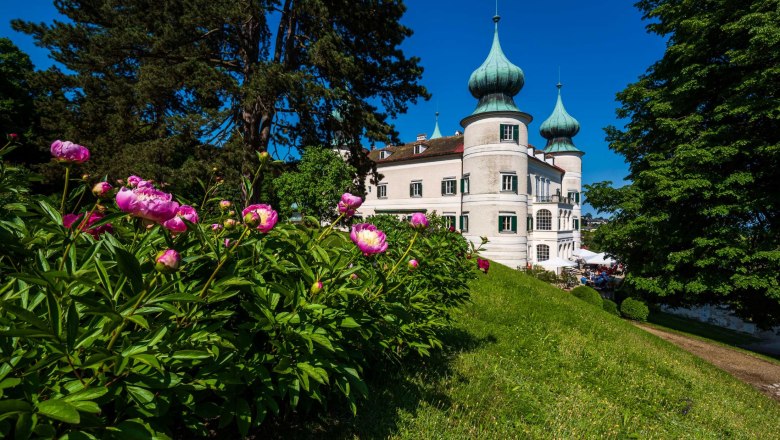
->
[13,0,427,192]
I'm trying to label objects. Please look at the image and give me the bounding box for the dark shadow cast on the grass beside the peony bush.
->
[261,329,496,439]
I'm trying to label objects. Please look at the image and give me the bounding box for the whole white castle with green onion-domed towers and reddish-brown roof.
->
[357,16,584,268]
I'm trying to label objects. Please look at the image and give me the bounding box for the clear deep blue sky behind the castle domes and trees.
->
[0,0,665,212]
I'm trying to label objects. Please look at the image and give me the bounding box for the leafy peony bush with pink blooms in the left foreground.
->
[0,140,487,439]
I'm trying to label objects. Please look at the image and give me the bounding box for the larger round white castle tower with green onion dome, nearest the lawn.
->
[461,15,532,268]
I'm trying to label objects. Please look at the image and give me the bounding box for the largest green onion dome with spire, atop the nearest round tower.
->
[469,15,525,114]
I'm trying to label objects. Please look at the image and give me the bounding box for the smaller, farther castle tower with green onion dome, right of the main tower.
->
[539,83,585,249]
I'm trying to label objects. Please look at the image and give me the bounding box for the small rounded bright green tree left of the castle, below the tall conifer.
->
[274,147,355,221]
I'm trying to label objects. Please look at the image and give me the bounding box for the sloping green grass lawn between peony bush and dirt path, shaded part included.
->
[266,264,780,439]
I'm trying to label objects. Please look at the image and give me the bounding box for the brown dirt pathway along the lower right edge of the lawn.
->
[634,323,780,401]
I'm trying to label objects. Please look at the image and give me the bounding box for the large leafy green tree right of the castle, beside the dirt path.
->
[587,0,780,325]
